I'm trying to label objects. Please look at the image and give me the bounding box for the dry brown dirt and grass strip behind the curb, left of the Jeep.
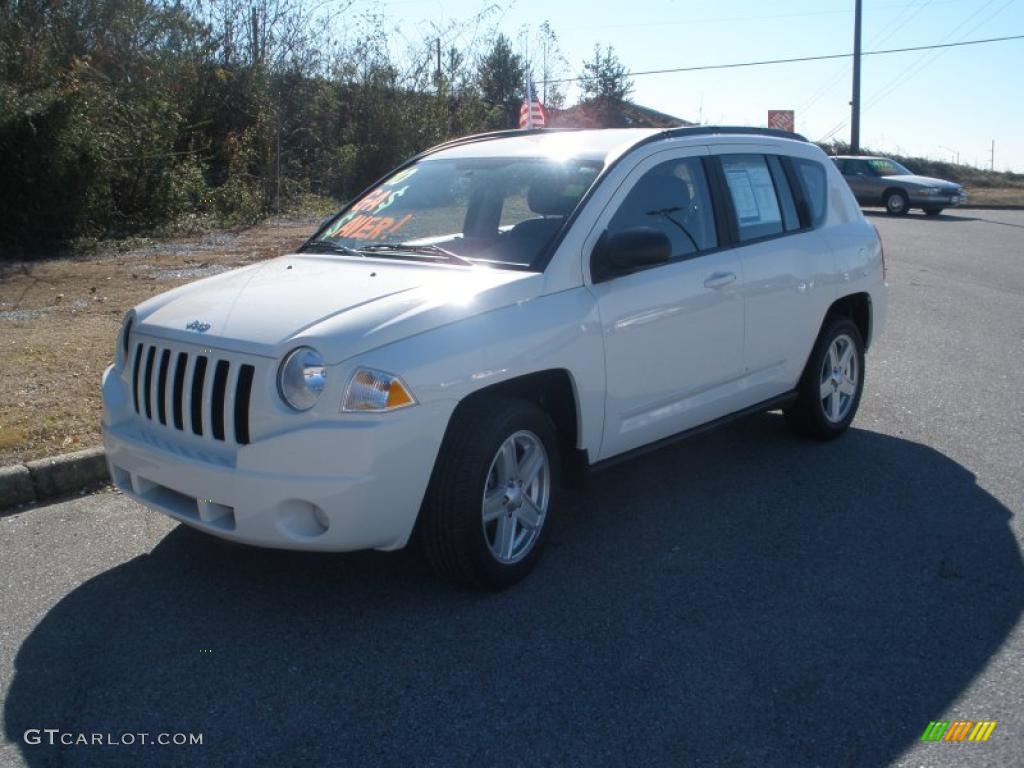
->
[0,218,316,466]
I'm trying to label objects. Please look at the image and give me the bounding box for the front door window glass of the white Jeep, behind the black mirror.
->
[608,158,718,259]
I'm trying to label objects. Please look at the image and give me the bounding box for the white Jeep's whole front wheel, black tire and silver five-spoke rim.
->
[421,397,559,590]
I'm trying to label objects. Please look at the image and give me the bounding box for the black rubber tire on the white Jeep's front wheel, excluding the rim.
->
[419,397,560,591]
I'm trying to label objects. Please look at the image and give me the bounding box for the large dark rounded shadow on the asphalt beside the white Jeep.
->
[4,414,1024,768]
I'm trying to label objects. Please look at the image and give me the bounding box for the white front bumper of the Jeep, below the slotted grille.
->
[103,368,455,552]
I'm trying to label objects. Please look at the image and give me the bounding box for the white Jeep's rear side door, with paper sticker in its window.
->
[717,147,835,404]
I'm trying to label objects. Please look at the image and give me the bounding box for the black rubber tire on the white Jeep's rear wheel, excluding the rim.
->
[783,315,864,440]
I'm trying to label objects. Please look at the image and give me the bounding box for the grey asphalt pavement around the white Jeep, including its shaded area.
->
[0,211,1024,768]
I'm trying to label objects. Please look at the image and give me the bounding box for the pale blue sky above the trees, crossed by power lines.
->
[370,0,1024,172]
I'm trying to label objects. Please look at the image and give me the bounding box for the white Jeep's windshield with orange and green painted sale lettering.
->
[305,158,602,268]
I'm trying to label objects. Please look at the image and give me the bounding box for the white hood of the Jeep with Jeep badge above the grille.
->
[135,254,544,364]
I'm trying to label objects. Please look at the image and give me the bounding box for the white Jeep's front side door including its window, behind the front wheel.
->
[588,150,744,459]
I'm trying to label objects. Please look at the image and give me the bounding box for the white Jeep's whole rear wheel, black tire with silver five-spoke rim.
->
[784,317,864,440]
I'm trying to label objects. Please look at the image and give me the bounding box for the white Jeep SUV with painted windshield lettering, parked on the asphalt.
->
[103,127,887,589]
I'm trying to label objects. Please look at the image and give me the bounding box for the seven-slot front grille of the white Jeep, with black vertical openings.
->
[131,342,256,445]
